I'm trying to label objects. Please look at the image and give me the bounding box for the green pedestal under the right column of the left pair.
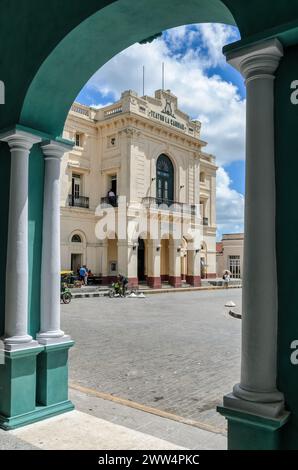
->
[36,341,74,406]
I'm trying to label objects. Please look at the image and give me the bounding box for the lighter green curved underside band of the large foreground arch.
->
[20,0,235,136]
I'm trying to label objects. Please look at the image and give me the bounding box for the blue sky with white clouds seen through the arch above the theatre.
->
[76,24,246,240]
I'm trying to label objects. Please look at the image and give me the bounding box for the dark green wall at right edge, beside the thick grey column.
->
[275,46,298,449]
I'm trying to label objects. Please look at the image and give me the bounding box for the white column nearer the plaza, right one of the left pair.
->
[37,141,70,344]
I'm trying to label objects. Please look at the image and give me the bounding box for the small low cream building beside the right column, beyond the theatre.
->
[216,233,244,278]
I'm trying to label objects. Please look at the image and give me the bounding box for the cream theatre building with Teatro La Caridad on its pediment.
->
[61,90,217,287]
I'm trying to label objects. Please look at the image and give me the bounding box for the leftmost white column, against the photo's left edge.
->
[0,130,41,350]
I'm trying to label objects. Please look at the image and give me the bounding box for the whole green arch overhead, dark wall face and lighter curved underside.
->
[0,0,298,136]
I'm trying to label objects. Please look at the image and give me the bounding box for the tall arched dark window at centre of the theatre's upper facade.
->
[156,154,174,204]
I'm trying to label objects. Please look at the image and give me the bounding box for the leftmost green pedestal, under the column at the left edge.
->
[0,346,43,421]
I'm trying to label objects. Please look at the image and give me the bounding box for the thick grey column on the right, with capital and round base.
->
[224,39,283,417]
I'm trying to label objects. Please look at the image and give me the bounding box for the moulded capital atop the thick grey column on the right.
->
[226,38,283,82]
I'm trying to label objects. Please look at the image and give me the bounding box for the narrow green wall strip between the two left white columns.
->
[28,145,44,337]
